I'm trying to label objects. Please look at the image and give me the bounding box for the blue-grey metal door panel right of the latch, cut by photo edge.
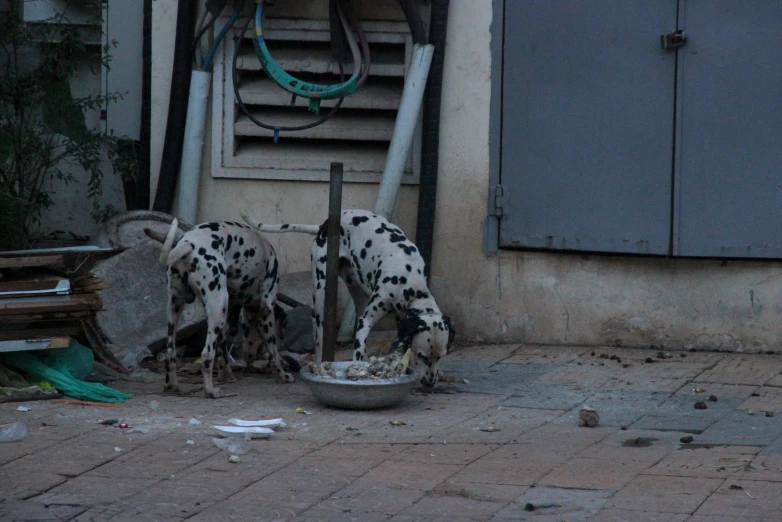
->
[673,0,782,258]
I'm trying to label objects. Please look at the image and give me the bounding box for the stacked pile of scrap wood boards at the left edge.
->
[0,246,117,352]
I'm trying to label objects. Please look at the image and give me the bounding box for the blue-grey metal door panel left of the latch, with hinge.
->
[499,0,680,254]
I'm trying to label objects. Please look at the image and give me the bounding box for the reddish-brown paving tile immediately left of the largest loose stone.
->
[435,406,565,444]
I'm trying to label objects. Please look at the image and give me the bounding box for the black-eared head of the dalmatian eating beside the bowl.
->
[391,308,456,388]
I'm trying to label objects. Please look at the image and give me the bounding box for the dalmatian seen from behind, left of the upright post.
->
[160,219,293,399]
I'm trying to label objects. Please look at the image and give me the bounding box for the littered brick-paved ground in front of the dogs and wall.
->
[0,345,782,522]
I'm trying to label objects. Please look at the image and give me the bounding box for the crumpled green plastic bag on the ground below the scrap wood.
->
[0,341,132,402]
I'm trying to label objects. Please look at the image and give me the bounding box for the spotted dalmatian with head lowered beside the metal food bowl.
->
[242,210,455,388]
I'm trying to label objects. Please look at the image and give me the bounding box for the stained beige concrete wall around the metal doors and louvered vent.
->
[153,0,782,351]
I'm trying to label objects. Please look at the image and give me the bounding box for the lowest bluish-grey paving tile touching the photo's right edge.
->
[697,410,782,446]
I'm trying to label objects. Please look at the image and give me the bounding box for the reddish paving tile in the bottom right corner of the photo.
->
[693,480,782,522]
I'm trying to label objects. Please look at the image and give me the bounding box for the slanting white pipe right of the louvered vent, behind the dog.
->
[337,44,434,342]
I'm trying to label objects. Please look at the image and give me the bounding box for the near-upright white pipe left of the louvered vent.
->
[177,71,212,225]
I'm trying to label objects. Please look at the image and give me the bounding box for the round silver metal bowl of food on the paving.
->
[299,361,417,410]
